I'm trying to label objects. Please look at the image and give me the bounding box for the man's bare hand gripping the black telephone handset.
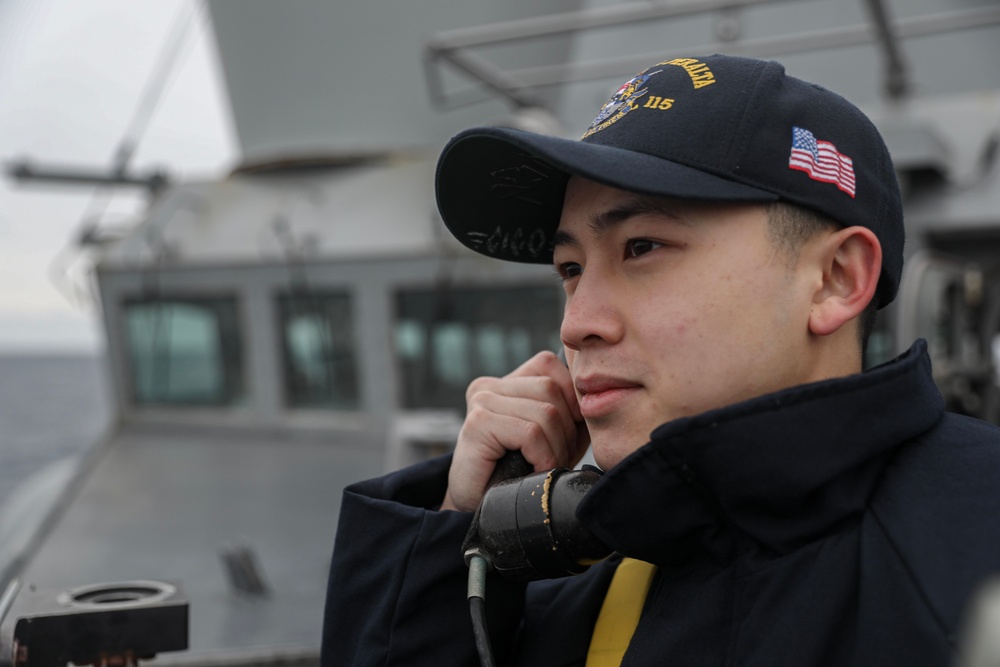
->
[441,352,590,512]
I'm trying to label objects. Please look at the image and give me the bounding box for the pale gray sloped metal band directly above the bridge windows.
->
[99,153,459,271]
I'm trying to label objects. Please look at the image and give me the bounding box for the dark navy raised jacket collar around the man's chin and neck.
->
[578,341,944,564]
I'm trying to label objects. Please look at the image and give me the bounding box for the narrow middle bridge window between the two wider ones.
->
[278,292,359,410]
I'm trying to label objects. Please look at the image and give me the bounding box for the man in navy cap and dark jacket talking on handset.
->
[323,56,1000,667]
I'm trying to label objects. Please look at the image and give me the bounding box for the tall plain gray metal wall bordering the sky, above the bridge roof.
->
[208,0,579,163]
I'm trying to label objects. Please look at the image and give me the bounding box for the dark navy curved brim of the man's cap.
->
[435,127,779,264]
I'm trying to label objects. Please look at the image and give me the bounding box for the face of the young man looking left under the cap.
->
[554,177,809,469]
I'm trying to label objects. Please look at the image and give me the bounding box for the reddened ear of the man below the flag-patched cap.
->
[809,227,882,336]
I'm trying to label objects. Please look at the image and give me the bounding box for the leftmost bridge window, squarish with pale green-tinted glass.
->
[125,298,244,406]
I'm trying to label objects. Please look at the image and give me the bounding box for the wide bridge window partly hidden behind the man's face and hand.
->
[395,286,562,410]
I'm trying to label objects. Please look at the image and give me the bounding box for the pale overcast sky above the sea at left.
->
[0,0,238,353]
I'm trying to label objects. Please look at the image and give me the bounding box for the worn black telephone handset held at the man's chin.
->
[462,451,612,581]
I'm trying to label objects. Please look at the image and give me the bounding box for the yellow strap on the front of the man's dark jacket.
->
[586,558,656,667]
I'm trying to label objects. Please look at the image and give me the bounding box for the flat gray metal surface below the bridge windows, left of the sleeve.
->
[14,427,383,665]
